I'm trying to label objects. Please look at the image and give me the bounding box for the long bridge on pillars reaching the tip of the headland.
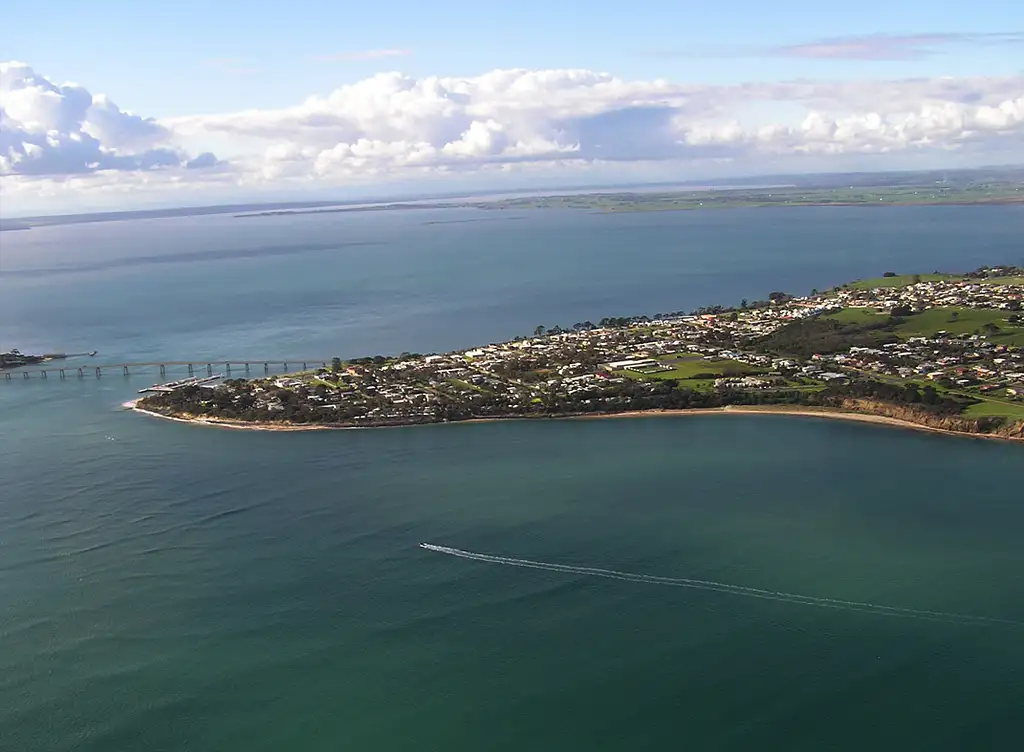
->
[2,358,330,381]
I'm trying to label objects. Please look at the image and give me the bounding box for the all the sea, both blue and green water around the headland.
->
[0,202,1024,752]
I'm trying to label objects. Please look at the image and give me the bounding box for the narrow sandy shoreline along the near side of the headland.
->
[123,400,1024,443]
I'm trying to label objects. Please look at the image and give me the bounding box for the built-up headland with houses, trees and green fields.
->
[134,265,1024,440]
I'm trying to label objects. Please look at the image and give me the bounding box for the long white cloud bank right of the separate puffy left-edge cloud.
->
[166,70,1024,178]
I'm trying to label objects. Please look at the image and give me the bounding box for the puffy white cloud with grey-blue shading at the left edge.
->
[0,62,219,178]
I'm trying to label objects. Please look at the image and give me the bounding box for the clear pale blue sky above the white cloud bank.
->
[8,0,1024,117]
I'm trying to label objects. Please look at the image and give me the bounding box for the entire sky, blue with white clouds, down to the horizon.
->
[0,0,1024,216]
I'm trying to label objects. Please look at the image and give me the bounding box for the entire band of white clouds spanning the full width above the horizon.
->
[0,64,1024,209]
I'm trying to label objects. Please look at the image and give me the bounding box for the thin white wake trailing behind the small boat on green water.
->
[420,543,1024,627]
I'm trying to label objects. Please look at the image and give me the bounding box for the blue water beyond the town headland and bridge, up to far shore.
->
[0,206,1024,360]
